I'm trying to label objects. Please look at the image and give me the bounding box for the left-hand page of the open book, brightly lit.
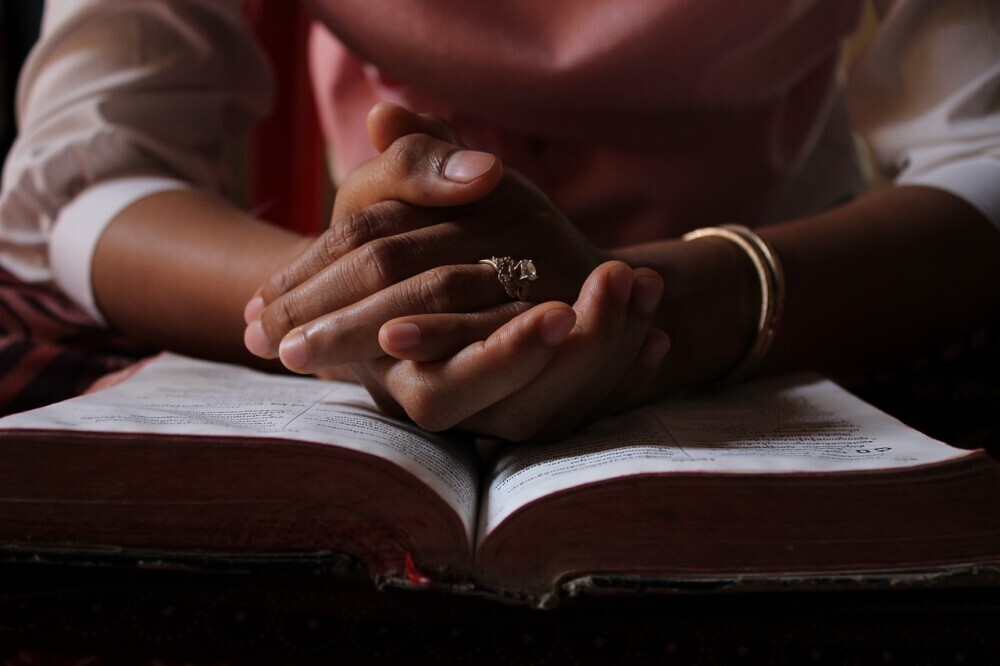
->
[0,354,478,537]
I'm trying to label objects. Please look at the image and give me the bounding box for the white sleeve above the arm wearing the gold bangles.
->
[848,0,1000,229]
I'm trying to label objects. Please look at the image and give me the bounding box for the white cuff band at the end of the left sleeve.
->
[49,176,192,325]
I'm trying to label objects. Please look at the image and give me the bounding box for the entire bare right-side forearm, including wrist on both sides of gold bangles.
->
[620,187,1000,392]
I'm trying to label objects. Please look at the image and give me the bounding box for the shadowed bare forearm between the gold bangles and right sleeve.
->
[761,187,1000,372]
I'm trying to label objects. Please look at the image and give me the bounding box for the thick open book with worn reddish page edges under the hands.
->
[0,355,1000,605]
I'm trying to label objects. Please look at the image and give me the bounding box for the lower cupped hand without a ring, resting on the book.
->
[351,261,670,441]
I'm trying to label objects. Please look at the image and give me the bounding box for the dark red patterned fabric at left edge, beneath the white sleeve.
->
[0,270,151,414]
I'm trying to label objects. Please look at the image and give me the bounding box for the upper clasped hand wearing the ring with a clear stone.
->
[245,105,603,372]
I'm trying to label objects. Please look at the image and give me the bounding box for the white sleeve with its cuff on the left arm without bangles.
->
[0,0,272,313]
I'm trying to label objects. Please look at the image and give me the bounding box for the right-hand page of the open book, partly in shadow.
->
[479,376,968,539]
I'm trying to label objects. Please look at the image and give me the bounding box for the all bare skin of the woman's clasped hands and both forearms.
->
[94,105,1000,440]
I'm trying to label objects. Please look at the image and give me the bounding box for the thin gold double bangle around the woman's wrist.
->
[681,224,785,384]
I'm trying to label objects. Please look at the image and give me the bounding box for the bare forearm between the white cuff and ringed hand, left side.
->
[92,190,307,362]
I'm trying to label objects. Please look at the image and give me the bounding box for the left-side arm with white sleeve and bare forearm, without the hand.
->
[0,0,302,359]
